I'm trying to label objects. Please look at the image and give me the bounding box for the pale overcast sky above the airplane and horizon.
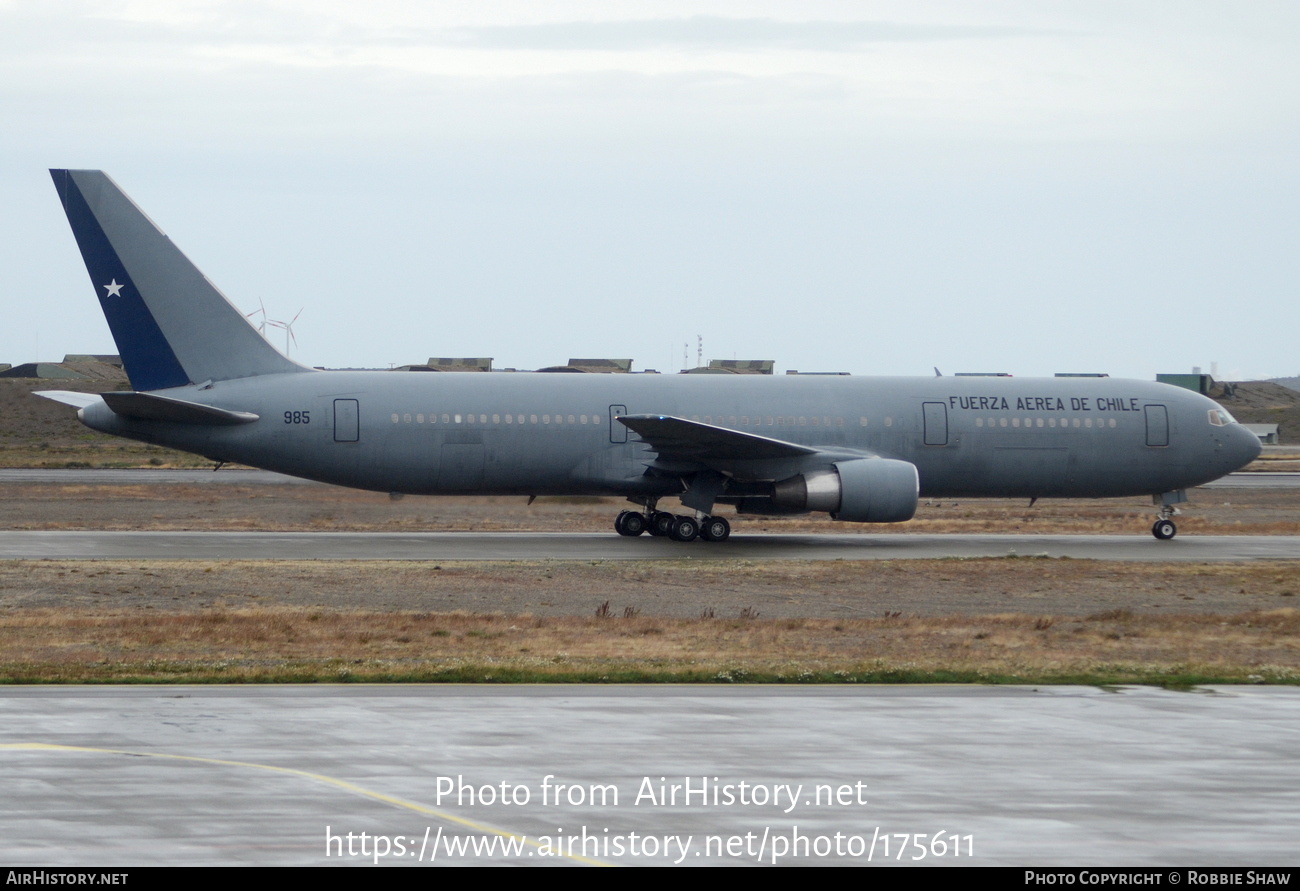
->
[0,0,1300,377]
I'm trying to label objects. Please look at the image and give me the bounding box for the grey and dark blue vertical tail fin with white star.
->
[49,170,311,392]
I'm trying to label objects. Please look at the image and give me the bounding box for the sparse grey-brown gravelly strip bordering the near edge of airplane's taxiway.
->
[0,555,1300,619]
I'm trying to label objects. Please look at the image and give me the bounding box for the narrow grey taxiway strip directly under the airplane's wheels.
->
[0,532,1300,562]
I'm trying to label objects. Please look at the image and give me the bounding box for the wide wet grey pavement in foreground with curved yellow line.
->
[0,685,1300,866]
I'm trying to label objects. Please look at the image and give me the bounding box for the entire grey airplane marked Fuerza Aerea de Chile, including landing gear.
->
[40,170,1260,541]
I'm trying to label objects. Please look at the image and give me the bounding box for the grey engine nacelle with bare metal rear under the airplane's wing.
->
[771,458,920,523]
